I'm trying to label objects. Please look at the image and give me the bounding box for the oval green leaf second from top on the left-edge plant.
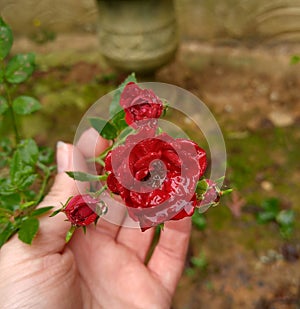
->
[5,53,35,84]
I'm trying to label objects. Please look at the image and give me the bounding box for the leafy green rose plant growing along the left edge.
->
[0,17,55,247]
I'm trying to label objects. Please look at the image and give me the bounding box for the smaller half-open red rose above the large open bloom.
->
[120,82,163,128]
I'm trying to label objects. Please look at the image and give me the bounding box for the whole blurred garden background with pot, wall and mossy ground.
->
[0,0,300,309]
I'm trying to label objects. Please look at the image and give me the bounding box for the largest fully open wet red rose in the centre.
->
[105,134,207,230]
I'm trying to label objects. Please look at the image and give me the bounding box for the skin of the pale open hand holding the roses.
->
[0,129,191,309]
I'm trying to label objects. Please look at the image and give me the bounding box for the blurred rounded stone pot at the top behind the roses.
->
[97,0,178,73]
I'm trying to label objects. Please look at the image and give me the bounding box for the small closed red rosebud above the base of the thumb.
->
[64,194,99,226]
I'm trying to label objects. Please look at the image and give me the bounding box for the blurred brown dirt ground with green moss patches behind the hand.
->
[7,37,300,309]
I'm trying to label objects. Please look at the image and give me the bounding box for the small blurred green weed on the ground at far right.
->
[256,198,295,238]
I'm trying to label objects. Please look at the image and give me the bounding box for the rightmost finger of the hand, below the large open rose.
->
[148,218,191,295]
